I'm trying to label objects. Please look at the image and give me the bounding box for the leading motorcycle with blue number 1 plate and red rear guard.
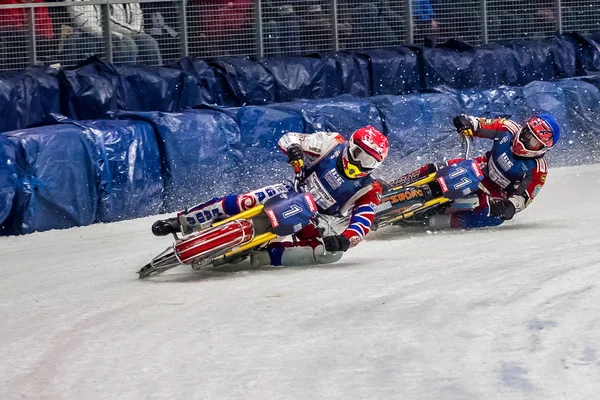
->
[138,172,317,279]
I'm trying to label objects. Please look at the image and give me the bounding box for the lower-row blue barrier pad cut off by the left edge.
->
[0,136,19,235]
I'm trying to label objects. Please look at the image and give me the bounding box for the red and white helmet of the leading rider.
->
[341,126,389,179]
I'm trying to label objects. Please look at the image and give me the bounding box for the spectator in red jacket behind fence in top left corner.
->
[0,0,55,69]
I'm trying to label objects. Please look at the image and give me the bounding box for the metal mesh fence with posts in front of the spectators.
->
[0,0,600,70]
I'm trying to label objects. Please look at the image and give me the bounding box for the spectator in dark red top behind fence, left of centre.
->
[188,0,255,57]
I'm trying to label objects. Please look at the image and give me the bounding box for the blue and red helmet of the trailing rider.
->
[512,114,560,157]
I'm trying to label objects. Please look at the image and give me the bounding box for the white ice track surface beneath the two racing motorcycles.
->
[0,165,600,400]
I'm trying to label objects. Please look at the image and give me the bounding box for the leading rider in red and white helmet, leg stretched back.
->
[152,126,389,266]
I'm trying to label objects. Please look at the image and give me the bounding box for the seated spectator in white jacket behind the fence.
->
[69,0,162,65]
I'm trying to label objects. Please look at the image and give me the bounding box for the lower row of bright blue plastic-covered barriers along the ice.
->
[0,76,600,234]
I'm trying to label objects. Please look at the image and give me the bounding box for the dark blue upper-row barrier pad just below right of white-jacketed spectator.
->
[116,65,204,112]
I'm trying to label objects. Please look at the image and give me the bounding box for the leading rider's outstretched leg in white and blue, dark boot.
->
[152,183,291,236]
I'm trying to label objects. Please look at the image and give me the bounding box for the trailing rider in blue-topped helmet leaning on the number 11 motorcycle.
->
[422,114,560,229]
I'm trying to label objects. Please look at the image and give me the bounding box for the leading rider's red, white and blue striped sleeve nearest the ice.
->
[342,181,382,247]
